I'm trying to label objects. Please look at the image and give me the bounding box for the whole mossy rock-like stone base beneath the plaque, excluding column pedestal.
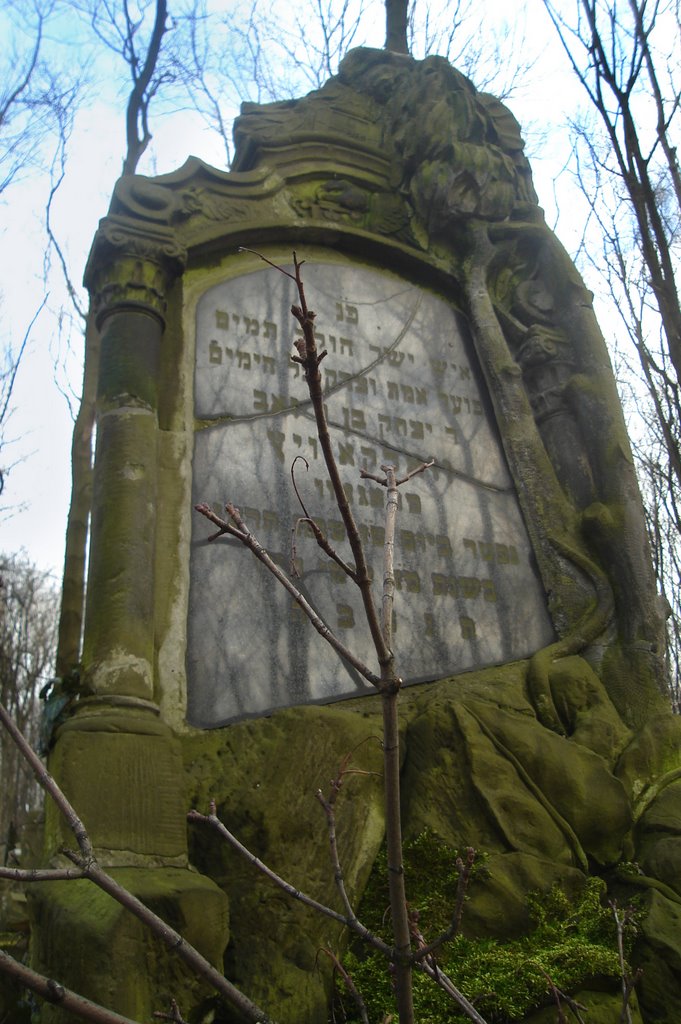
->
[178,658,667,1024]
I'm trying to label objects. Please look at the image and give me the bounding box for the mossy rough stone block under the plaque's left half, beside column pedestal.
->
[184,708,383,1024]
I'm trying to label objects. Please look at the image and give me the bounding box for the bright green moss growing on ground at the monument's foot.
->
[337,833,634,1024]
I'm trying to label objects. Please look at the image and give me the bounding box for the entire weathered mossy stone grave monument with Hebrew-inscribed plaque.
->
[27,50,681,1024]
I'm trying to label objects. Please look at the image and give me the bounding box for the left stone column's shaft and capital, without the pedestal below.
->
[83,218,185,700]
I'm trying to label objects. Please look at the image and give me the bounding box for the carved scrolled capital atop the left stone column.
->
[85,217,186,328]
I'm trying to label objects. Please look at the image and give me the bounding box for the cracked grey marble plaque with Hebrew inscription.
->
[187,263,553,727]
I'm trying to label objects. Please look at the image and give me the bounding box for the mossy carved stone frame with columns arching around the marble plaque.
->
[78,51,662,730]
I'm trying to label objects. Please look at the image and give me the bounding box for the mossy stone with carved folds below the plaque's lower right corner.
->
[403,671,632,870]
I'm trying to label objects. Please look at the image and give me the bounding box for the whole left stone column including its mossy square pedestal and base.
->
[32,217,227,1024]
